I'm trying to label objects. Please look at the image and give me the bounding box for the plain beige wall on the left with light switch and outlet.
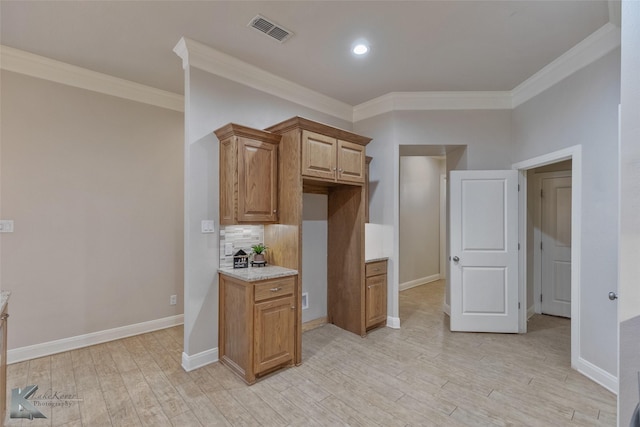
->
[0,71,184,349]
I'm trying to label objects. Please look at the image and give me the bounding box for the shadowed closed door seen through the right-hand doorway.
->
[540,176,571,317]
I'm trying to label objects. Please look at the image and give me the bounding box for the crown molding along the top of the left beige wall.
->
[0,45,184,112]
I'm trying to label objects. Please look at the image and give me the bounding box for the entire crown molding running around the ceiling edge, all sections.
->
[0,22,620,122]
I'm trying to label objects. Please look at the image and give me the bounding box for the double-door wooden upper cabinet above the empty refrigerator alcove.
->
[267,117,371,185]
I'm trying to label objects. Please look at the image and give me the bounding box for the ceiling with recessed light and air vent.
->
[0,0,609,105]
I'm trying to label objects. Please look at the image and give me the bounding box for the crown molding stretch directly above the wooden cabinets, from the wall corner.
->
[173,37,353,122]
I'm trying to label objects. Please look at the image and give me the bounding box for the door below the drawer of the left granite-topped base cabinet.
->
[254,296,295,374]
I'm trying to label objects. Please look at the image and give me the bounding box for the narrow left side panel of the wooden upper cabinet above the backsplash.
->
[220,136,238,224]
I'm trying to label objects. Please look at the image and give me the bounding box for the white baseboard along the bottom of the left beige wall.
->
[7,314,184,363]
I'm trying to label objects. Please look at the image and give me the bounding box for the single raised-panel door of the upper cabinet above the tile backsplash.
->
[238,138,278,222]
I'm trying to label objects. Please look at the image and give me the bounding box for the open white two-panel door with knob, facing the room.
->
[449,170,518,332]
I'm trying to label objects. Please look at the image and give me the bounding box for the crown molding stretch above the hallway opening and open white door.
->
[353,91,511,122]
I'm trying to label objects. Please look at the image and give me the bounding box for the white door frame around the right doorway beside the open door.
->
[512,145,591,376]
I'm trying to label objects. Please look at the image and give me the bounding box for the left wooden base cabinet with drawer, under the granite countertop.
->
[218,273,299,384]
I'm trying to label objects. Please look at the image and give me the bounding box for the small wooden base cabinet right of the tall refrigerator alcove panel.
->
[365,260,387,330]
